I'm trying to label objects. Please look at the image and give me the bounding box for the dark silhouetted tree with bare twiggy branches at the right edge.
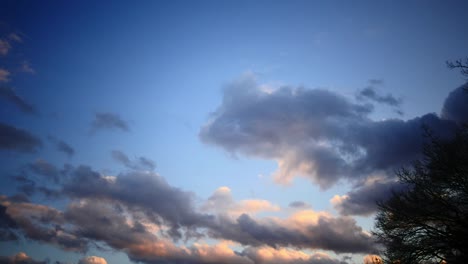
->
[374,125,468,264]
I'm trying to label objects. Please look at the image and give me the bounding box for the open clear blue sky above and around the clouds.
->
[0,1,468,221]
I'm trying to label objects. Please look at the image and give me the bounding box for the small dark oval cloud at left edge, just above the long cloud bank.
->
[0,123,42,152]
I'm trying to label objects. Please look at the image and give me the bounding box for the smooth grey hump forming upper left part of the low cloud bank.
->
[63,166,210,239]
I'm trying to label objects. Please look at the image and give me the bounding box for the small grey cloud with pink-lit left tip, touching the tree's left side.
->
[331,181,407,216]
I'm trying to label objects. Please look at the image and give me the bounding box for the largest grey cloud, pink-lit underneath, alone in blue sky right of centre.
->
[199,76,456,188]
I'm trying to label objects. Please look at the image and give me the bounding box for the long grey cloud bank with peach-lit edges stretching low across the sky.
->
[0,163,373,258]
